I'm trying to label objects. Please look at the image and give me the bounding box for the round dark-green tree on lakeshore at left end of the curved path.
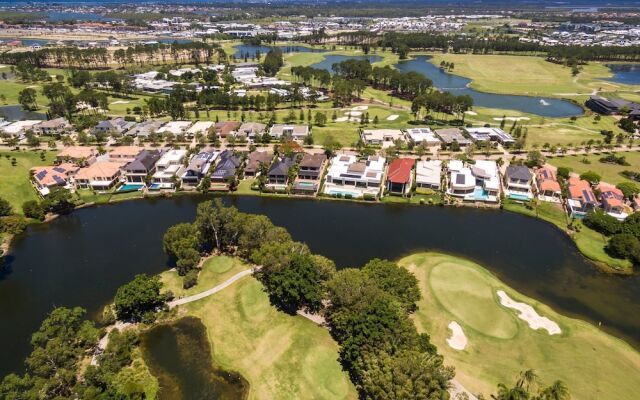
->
[114,274,165,322]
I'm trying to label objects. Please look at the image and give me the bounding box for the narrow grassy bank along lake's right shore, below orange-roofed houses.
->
[503,200,633,274]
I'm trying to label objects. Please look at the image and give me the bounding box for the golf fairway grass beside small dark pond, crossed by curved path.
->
[162,257,357,399]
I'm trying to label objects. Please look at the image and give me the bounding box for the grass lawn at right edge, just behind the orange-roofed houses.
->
[549,151,640,184]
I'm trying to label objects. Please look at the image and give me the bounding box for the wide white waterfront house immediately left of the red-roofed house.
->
[324,154,386,198]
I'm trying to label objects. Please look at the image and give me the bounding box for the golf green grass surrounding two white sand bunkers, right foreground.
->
[400,253,640,400]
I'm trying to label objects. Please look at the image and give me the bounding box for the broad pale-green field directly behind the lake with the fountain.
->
[424,54,621,97]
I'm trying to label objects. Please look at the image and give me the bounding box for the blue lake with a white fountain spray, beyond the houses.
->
[395,56,583,117]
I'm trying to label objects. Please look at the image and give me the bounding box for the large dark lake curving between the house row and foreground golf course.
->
[0,195,640,375]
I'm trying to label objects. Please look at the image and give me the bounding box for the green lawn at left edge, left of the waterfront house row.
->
[0,150,56,214]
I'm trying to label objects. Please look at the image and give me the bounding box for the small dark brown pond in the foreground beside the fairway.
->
[140,317,248,400]
